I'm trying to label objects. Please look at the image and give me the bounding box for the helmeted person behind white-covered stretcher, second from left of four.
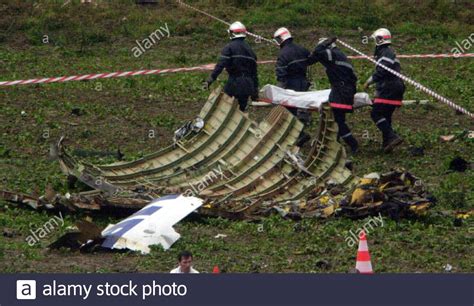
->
[273,28,311,147]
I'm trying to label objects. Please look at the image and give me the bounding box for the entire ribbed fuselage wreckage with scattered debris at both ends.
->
[2,88,436,219]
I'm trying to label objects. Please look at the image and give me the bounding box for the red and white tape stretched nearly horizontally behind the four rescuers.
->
[0,53,474,86]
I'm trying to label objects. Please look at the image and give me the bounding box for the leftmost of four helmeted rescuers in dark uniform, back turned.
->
[206,21,258,111]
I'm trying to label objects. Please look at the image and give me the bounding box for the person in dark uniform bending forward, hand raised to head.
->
[308,37,359,153]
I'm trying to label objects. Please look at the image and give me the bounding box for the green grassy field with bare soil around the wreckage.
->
[0,0,474,273]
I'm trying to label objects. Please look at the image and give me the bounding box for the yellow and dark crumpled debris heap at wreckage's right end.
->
[267,169,435,219]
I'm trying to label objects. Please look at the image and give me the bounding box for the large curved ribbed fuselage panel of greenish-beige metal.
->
[53,89,356,217]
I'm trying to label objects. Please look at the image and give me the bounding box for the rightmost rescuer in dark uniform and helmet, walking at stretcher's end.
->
[364,28,405,152]
